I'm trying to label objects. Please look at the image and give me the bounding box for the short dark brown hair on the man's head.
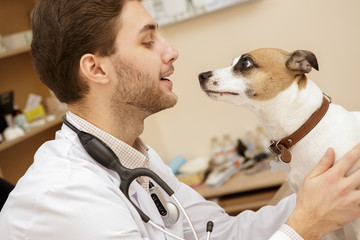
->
[31,0,126,103]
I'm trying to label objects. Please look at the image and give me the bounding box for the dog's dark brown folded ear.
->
[286,50,319,73]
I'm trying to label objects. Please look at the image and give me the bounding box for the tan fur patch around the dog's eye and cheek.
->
[233,49,306,100]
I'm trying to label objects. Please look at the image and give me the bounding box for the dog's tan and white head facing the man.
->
[199,48,319,105]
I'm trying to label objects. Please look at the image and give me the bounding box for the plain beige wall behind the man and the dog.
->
[142,0,360,162]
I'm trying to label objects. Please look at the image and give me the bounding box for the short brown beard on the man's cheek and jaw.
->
[111,60,177,116]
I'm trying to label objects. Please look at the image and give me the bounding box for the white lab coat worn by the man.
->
[0,119,295,240]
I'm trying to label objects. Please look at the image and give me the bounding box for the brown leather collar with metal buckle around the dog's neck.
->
[269,93,331,163]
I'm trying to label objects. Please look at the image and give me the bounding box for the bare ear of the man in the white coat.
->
[79,53,109,84]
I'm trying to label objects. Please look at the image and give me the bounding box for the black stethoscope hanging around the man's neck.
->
[62,116,213,240]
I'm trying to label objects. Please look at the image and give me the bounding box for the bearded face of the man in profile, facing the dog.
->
[110,1,178,114]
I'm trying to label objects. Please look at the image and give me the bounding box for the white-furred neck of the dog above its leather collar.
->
[250,79,323,140]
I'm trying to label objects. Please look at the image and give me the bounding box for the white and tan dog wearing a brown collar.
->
[199,49,360,240]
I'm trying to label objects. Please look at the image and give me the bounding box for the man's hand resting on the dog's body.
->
[286,144,360,240]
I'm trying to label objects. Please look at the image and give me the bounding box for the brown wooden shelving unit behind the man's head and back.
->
[0,0,61,184]
